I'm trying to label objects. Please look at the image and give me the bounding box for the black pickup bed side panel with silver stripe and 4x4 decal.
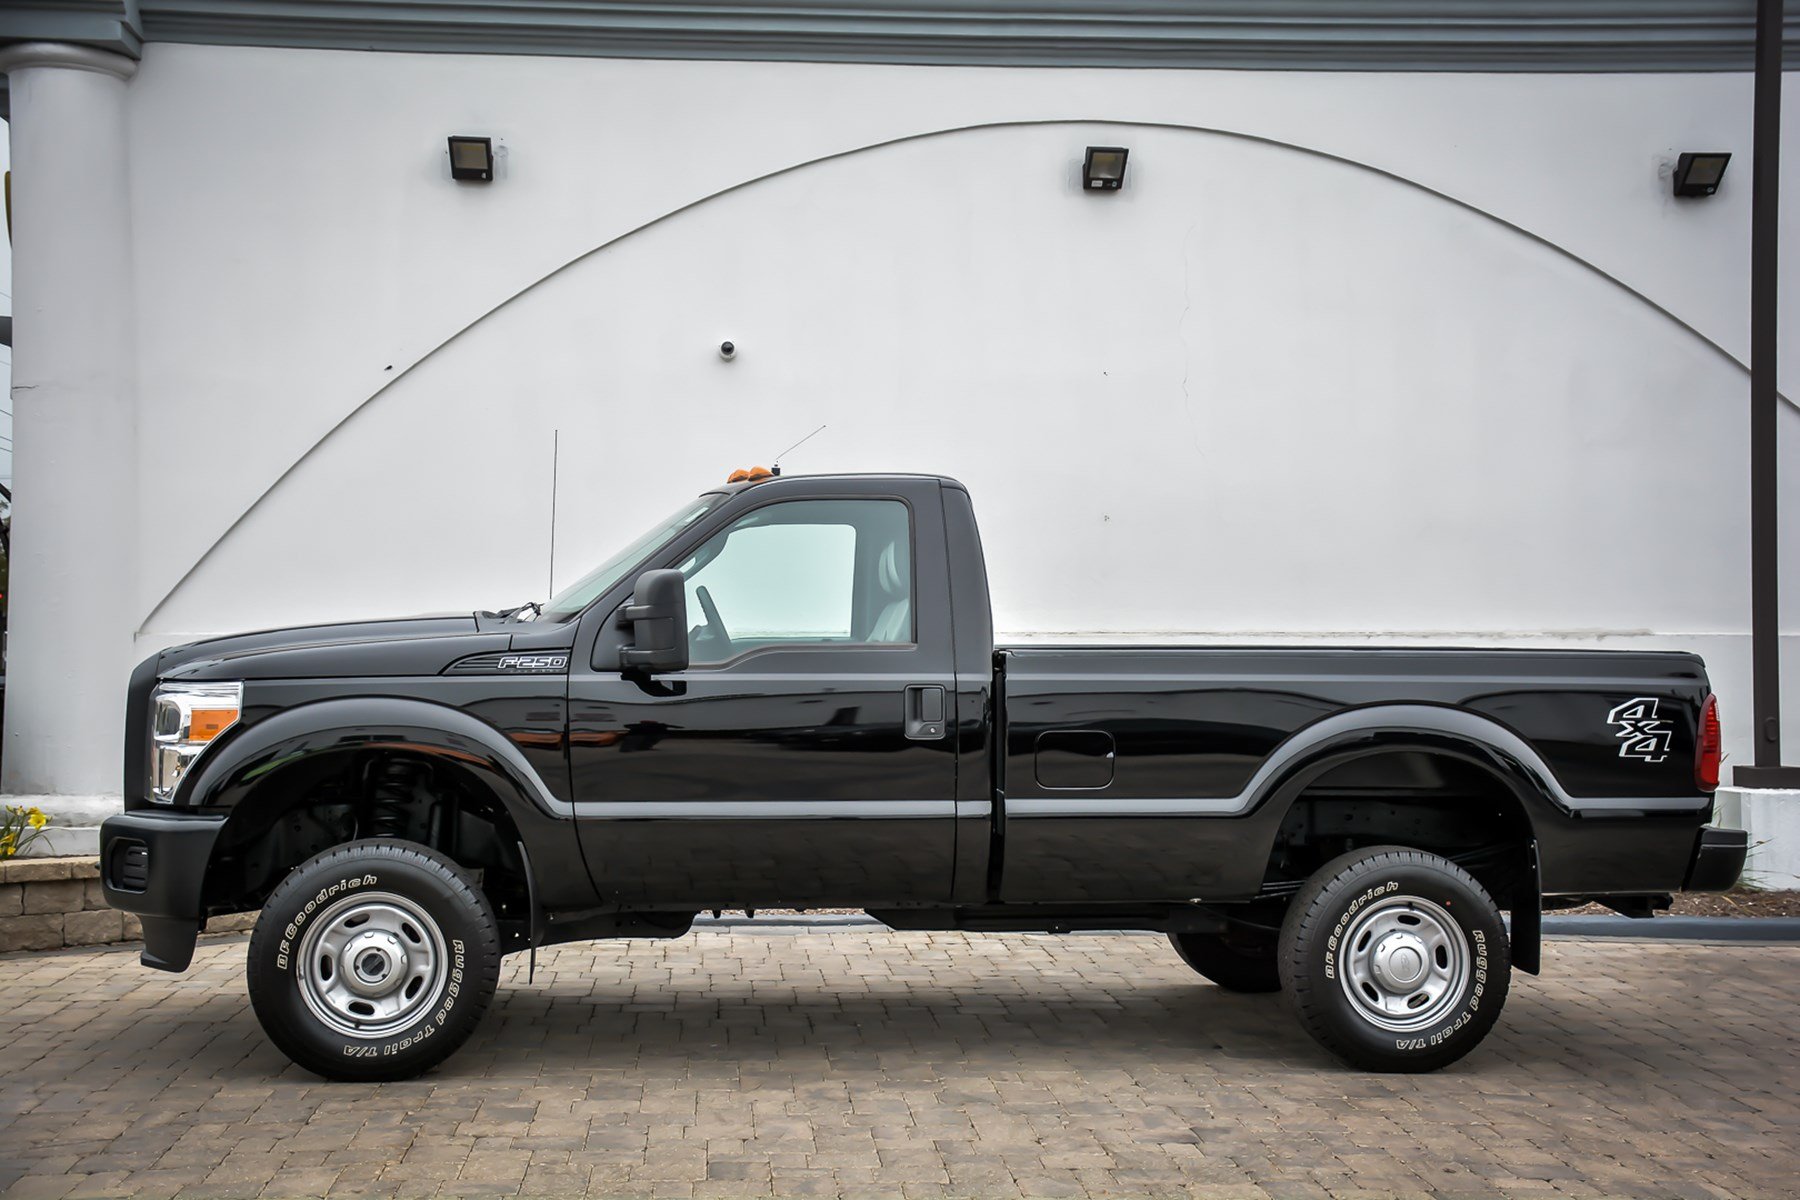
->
[1001,648,1712,901]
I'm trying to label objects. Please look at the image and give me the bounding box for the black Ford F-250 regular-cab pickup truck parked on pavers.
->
[101,471,1744,1079]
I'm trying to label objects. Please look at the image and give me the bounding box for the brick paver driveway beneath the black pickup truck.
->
[0,930,1800,1198]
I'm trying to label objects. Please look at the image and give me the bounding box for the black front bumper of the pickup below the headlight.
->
[101,810,225,972]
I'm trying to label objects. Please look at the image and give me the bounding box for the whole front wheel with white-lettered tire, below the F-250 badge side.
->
[247,840,500,1081]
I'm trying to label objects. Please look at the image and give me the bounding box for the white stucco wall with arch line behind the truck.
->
[7,45,1800,805]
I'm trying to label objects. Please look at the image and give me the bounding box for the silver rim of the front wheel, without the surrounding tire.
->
[297,892,446,1038]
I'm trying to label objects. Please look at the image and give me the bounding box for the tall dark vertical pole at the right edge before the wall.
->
[1735,0,1800,786]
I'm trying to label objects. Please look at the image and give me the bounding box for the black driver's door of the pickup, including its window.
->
[569,479,956,909]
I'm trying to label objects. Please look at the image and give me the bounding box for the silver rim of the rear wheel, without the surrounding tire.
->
[1337,896,1469,1033]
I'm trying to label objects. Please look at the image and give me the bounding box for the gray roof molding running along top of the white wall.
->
[0,0,1800,72]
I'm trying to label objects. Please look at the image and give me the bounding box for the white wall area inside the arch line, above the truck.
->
[140,122,1800,639]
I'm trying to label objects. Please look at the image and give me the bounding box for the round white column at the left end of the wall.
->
[0,41,137,853]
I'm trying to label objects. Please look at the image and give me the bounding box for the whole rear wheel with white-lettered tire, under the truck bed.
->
[1280,846,1512,1072]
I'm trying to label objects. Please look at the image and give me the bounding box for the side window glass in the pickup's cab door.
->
[680,500,913,666]
